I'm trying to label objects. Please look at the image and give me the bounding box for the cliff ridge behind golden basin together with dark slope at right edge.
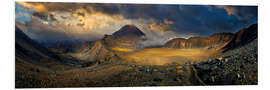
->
[164,24,258,52]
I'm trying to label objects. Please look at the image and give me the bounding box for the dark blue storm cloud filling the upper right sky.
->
[83,4,258,36]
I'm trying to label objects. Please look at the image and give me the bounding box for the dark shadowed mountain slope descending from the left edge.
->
[15,26,82,68]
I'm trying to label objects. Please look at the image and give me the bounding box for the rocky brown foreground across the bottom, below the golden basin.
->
[16,37,258,88]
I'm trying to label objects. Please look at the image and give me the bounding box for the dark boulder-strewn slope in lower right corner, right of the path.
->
[192,39,258,85]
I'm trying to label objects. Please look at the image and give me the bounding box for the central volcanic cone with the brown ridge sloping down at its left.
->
[72,25,145,62]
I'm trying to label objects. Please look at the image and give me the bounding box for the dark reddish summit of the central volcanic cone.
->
[113,25,145,37]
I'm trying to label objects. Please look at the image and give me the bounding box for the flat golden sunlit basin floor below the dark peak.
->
[122,48,218,65]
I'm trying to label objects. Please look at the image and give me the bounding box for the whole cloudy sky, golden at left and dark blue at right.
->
[15,2,258,45]
